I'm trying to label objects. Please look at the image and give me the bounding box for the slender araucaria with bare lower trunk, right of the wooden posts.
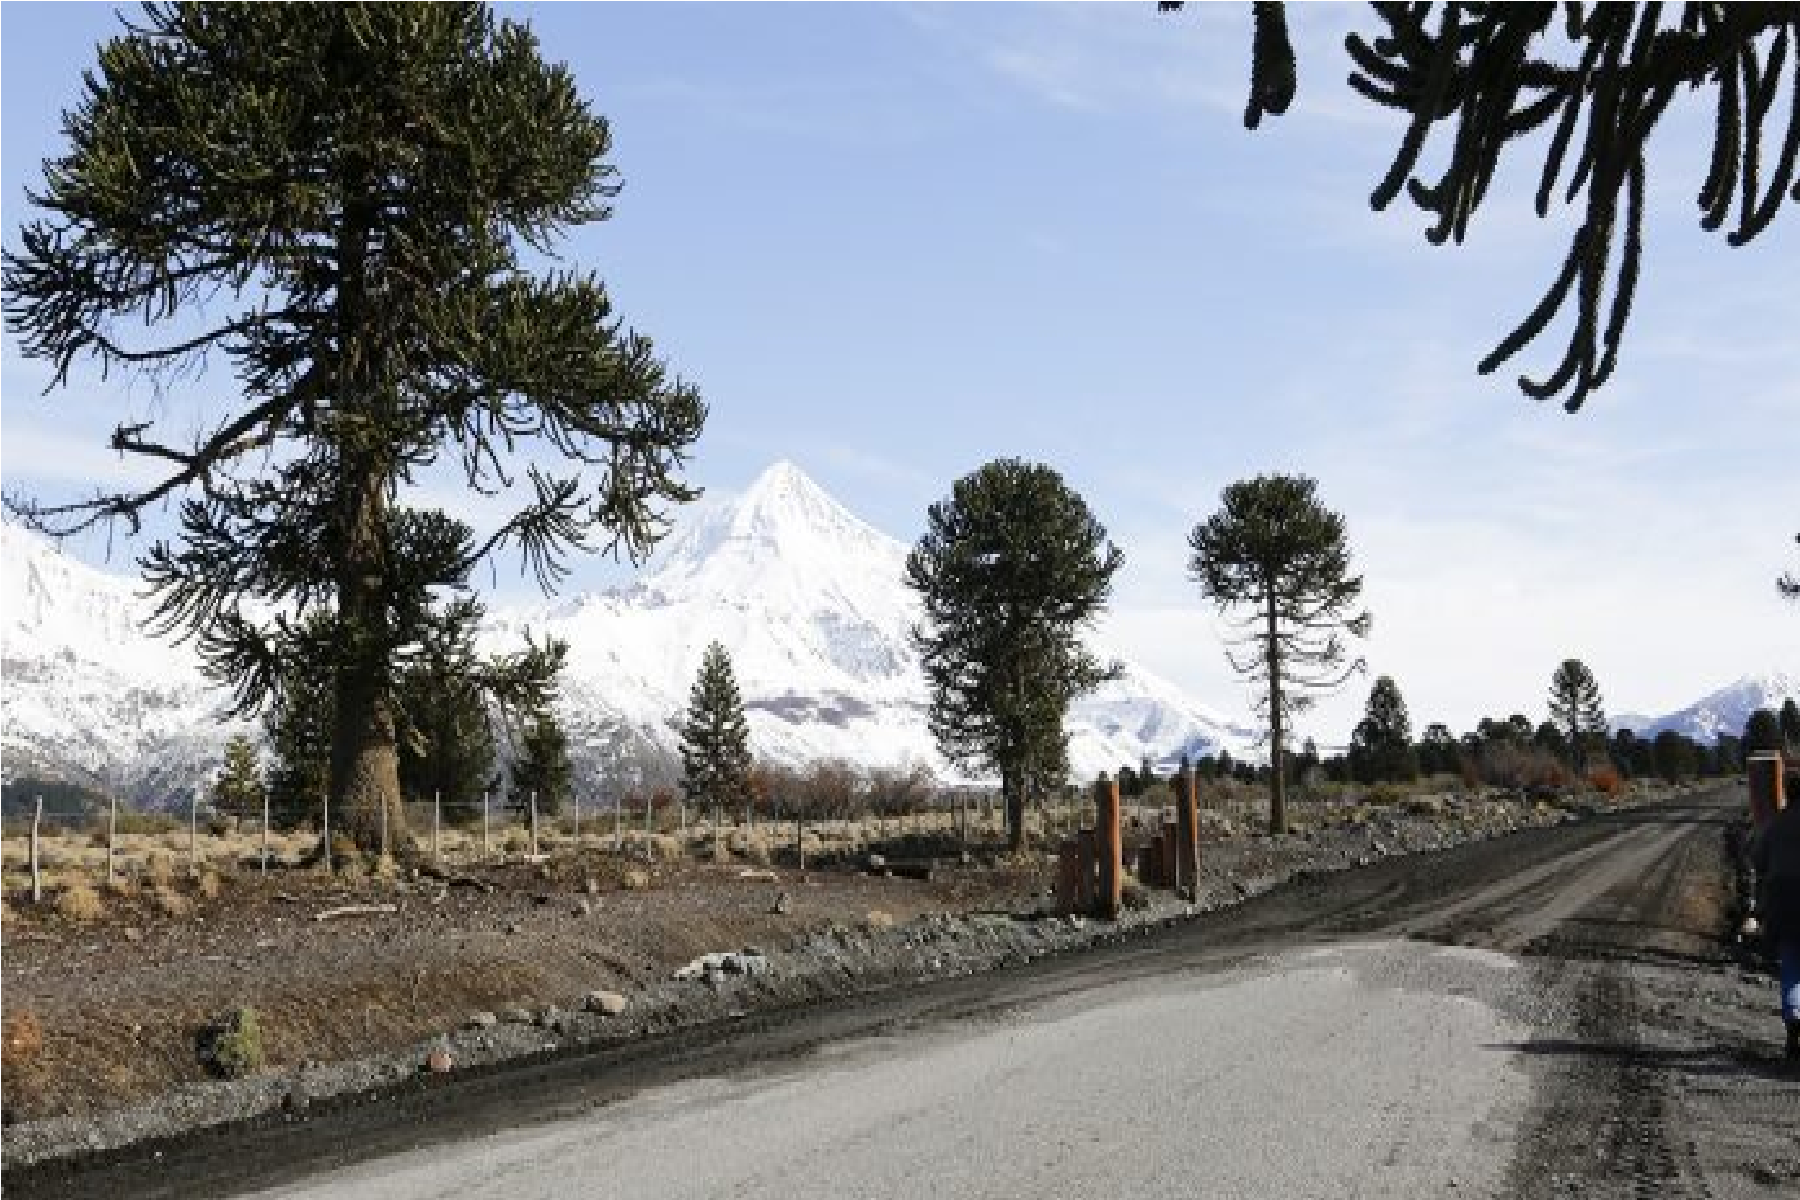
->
[1188,475,1370,833]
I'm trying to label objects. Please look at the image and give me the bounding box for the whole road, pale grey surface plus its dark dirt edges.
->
[7,788,1800,1200]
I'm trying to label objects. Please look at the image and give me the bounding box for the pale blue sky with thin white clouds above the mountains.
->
[0,4,1800,741]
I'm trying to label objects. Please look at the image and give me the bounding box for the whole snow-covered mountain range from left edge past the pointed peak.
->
[0,462,1255,801]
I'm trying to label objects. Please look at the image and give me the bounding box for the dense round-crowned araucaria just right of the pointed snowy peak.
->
[905,459,1125,847]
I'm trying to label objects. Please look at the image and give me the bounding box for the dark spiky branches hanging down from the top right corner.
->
[1157,4,1800,412]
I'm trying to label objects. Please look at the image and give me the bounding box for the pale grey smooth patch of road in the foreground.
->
[250,943,1530,1200]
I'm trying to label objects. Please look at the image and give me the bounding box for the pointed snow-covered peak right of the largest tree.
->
[491,462,1255,788]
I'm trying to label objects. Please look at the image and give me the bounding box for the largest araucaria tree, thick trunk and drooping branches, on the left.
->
[5,4,706,847]
